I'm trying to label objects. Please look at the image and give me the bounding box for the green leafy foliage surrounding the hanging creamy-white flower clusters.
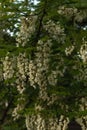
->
[0,0,87,130]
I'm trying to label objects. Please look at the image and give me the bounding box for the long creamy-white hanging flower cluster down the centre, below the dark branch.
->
[35,40,52,86]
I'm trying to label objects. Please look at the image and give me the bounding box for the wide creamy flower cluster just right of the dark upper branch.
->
[44,20,65,43]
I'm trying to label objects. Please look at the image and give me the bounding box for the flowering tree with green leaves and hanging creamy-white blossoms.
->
[0,0,87,130]
